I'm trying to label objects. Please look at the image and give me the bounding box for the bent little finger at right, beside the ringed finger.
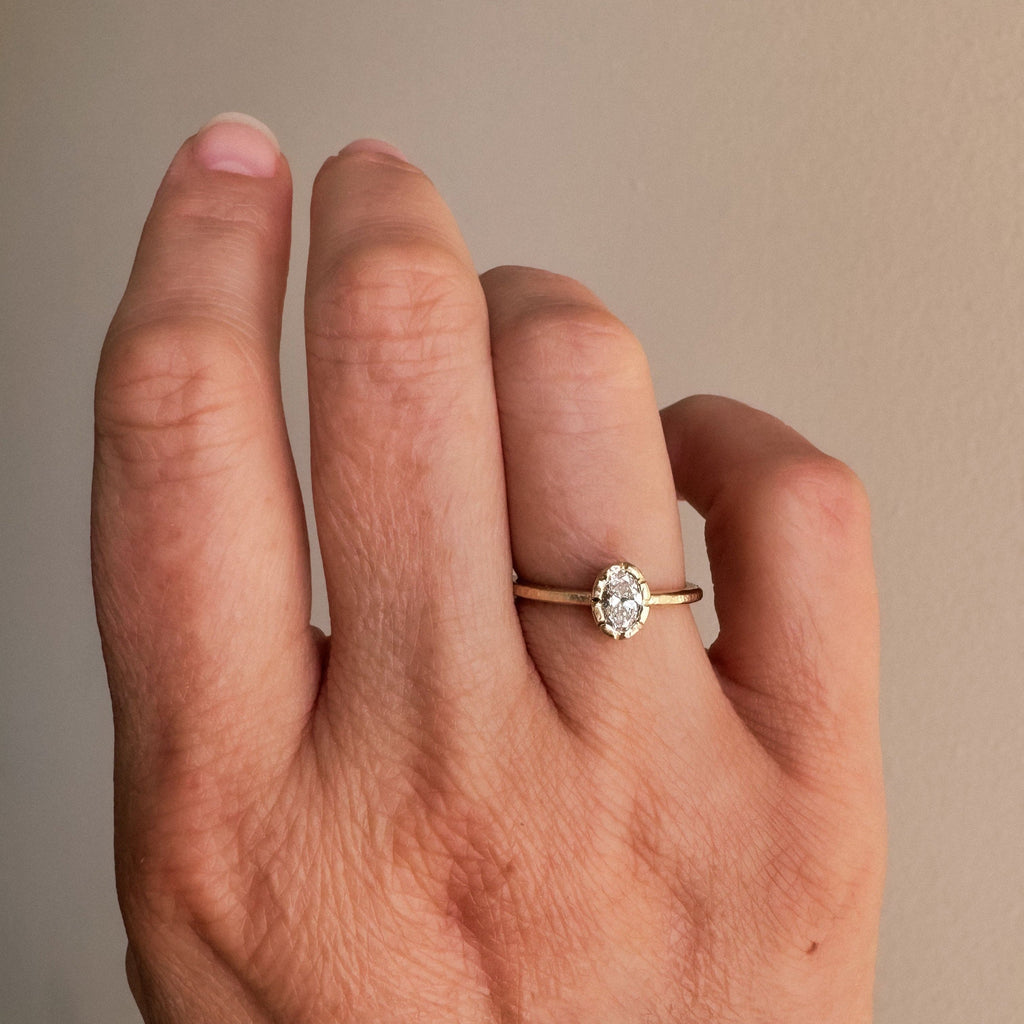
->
[662,396,879,777]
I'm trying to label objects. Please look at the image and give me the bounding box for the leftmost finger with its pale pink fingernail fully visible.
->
[93,121,316,770]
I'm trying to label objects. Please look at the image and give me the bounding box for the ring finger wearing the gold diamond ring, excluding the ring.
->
[482,267,720,737]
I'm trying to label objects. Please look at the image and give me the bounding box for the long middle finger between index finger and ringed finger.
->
[306,141,522,728]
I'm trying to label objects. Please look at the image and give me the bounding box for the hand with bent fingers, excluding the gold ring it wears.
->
[93,114,884,1024]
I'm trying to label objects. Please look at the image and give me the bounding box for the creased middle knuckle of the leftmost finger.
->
[95,315,261,472]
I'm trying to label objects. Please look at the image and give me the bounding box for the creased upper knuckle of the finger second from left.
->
[308,236,483,380]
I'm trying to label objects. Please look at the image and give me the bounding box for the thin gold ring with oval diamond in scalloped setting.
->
[512,562,703,640]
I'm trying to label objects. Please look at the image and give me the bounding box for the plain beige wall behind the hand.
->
[0,0,1024,1024]
